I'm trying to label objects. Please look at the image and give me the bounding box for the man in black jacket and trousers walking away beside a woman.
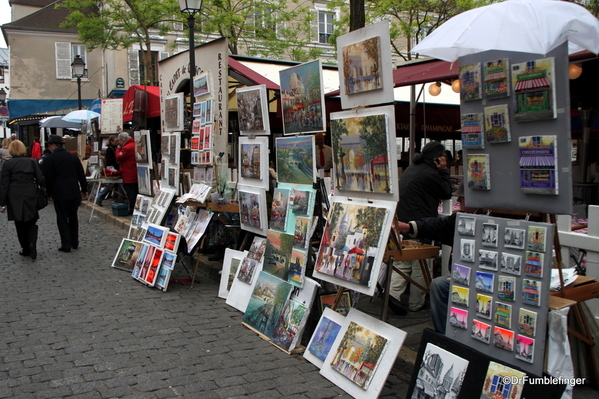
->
[40,134,87,252]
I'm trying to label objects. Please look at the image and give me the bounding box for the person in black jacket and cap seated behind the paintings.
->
[389,141,452,312]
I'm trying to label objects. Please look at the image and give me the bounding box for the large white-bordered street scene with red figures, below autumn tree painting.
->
[313,196,397,296]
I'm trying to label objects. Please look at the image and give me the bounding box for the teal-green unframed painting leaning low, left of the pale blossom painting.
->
[242,271,292,338]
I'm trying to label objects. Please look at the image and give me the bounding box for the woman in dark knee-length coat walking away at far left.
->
[0,140,44,260]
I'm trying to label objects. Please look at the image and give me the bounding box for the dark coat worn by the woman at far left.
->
[0,157,44,222]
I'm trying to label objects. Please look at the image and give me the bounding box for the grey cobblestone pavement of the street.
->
[0,203,412,399]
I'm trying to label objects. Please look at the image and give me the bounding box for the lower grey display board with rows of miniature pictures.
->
[446,213,554,375]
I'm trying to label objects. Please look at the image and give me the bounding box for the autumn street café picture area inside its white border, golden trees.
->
[331,112,393,194]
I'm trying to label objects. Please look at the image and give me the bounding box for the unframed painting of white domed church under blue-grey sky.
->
[279,60,326,134]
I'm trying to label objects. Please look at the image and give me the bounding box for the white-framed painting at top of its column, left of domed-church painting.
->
[235,85,270,135]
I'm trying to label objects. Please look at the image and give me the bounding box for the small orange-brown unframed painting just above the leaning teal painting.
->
[262,229,293,281]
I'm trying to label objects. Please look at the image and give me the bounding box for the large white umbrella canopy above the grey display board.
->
[411,0,599,62]
